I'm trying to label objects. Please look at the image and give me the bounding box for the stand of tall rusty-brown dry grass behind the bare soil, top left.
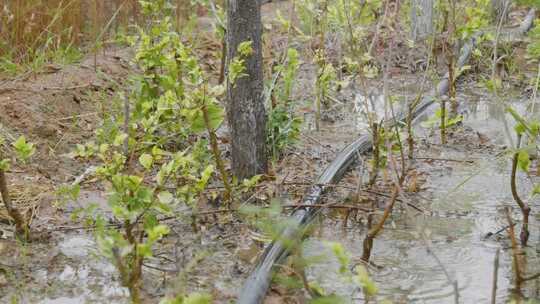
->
[0,0,205,75]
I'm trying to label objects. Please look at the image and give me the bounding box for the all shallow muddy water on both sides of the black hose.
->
[0,64,540,304]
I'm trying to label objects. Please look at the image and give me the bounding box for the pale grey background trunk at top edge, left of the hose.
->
[411,0,433,41]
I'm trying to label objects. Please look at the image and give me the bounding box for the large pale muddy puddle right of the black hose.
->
[304,91,540,303]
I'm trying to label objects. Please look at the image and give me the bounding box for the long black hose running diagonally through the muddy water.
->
[237,9,536,304]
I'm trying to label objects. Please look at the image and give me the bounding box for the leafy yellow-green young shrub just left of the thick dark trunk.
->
[70,0,227,303]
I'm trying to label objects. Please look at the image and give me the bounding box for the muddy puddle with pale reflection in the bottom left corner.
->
[0,233,128,304]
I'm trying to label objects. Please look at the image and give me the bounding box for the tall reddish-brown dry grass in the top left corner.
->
[0,0,187,64]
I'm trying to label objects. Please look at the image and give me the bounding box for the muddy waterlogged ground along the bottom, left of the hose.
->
[0,186,253,304]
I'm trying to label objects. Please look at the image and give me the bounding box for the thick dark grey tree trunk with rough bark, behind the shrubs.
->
[227,0,267,179]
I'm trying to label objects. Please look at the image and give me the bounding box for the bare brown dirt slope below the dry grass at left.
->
[0,49,130,182]
